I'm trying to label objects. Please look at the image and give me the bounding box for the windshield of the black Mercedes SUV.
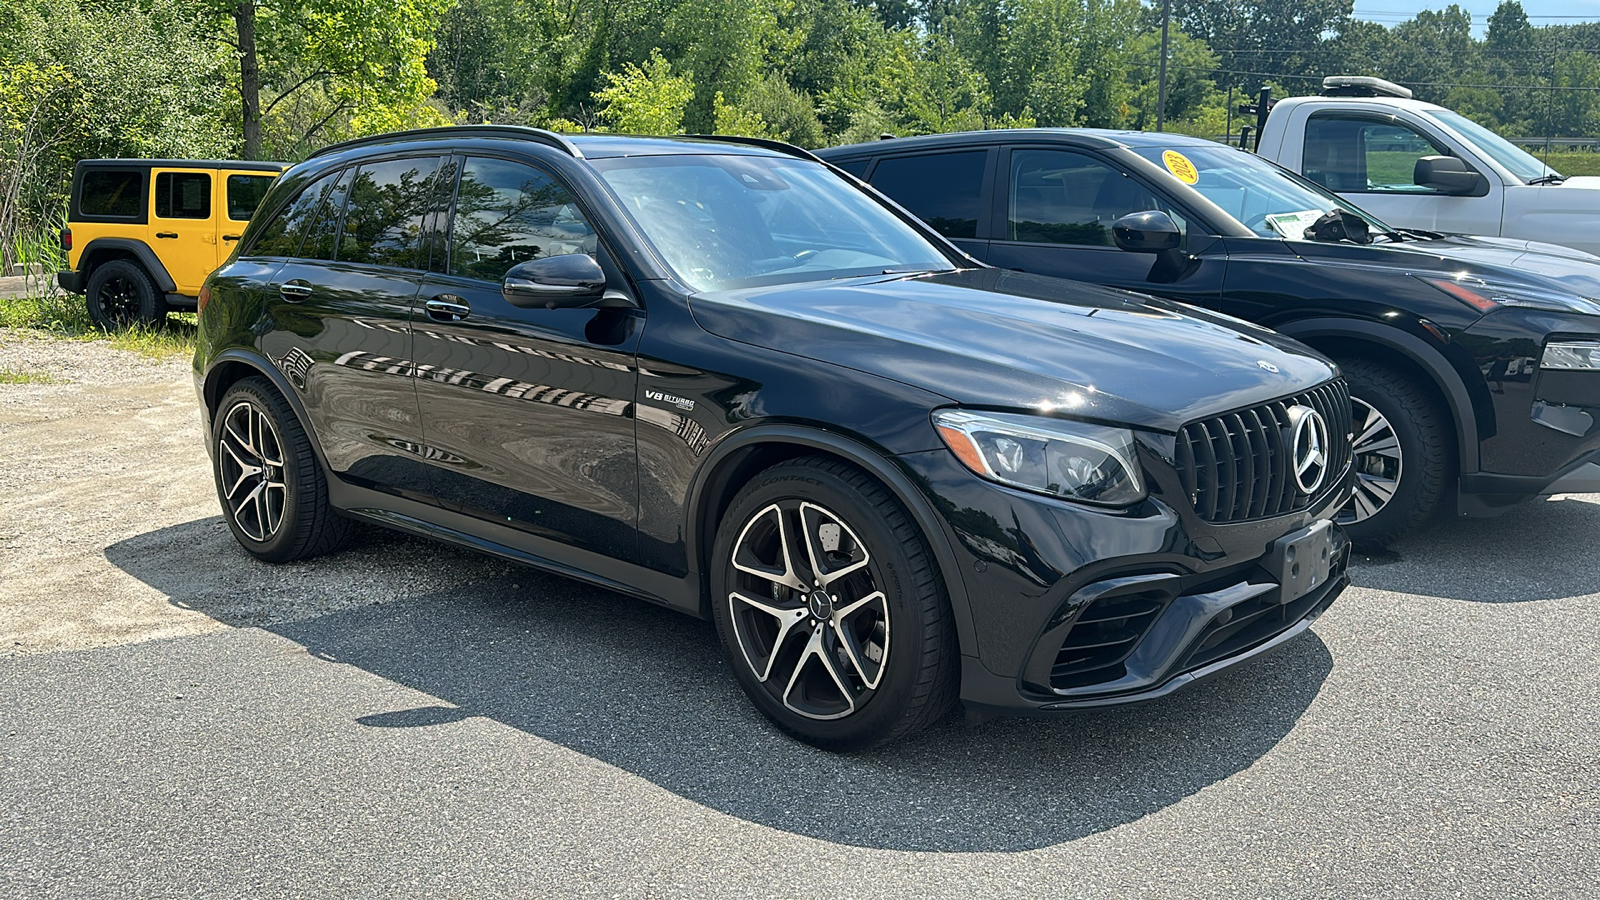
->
[594,155,955,290]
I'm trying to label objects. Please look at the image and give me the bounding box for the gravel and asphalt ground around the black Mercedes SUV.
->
[0,331,1600,898]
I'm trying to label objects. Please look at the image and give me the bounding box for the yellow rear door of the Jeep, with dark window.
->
[147,168,218,296]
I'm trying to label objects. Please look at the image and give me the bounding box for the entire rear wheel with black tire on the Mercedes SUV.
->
[211,376,350,562]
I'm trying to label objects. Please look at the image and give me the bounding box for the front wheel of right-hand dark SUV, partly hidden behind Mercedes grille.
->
[1339,359,1456,548]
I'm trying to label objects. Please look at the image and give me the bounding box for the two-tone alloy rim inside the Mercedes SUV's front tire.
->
[726,500,890,719]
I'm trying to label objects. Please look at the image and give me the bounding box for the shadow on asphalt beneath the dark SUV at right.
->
[1350,495,1600,604]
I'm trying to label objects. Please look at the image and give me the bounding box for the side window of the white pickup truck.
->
[1301,114,1450,194]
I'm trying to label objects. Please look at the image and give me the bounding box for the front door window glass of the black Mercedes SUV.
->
[450,159,598,282]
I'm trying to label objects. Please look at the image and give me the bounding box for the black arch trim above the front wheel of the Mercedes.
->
[683,424,978,657]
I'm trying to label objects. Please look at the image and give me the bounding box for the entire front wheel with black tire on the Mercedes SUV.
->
[710,458,958,751]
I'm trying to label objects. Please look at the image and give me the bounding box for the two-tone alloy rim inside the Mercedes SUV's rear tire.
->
[218,400,288,543]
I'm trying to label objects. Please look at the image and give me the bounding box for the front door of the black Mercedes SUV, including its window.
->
[414,155,643,560]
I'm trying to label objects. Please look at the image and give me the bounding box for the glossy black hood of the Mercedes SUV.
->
[690,269,1334,431]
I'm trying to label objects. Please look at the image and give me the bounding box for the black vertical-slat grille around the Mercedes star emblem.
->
[1178,378,1350,524]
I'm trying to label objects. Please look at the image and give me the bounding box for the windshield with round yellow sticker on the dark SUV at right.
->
[1133,144,1394,240]
